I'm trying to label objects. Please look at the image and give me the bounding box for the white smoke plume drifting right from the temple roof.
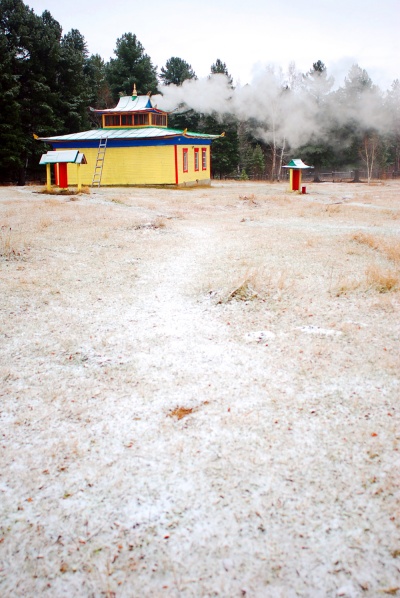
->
[153,65,390,147]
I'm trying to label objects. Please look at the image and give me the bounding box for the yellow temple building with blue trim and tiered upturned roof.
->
[39,89,219,186]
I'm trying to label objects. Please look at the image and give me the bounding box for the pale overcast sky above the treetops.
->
[25,0,400,90]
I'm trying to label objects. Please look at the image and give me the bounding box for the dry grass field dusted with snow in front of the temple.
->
[0,181,400,598]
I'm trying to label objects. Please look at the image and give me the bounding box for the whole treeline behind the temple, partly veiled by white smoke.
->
[0,0,400,185]
